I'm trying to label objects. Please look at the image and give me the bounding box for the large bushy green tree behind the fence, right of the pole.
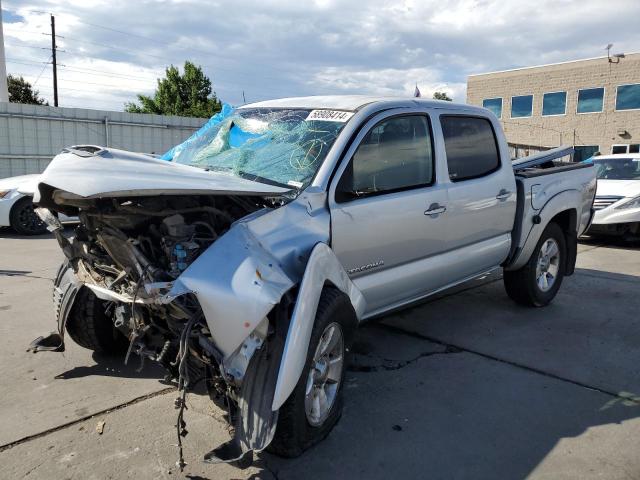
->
[125,61,222,118]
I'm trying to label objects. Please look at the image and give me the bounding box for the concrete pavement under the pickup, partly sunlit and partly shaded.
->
[0,231,640,479]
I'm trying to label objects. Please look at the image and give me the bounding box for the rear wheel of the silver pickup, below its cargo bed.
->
[503,223,567,307]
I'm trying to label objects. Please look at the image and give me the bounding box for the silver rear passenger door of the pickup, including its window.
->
[438,112,517,280]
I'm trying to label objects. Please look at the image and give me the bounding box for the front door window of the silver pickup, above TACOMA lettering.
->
[336,115,434,202]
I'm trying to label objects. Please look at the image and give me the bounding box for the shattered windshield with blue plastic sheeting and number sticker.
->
[172,108,353,189]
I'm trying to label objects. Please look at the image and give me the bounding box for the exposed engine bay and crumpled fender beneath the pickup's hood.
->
[32,189,304,463]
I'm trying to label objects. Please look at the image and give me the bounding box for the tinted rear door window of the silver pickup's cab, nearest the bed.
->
[440,115,500,182]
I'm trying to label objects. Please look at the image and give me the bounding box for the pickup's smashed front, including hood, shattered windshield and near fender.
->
[32,108,364,468]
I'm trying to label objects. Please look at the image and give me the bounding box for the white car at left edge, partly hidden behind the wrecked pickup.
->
[0,174,47,235]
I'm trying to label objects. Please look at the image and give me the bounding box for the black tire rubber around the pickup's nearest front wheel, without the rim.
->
[267,288,356,458]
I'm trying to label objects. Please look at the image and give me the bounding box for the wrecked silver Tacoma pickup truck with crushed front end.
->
[32,96,596,463]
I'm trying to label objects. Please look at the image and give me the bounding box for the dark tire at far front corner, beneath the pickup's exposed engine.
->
[66,287,127,353]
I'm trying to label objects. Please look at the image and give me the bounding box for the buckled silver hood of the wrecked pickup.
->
[34,143,289,203]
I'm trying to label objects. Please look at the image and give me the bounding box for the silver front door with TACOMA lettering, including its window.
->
[329,109,447,315]
